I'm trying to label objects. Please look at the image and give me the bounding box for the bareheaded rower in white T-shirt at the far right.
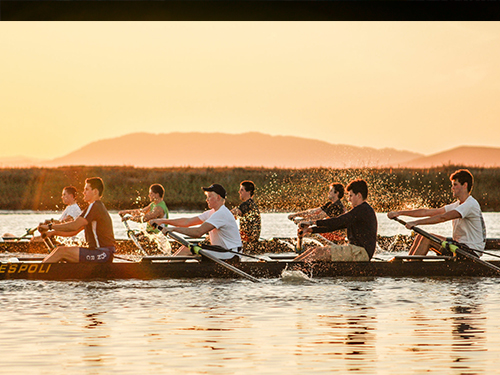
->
[387,169,486,257]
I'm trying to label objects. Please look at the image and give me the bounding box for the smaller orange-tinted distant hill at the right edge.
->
[401,146,500,168]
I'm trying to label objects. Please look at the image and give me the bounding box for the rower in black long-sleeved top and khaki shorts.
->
[294,180,377,262]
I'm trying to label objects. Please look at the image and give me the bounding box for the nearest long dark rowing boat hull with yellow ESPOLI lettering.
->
[0,255,500,280]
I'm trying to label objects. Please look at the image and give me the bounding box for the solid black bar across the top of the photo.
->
[0,0,500,21]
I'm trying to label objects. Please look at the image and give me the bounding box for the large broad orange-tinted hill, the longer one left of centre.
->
[44,132,423,168]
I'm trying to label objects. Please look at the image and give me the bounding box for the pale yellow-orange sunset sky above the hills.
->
[0,22,500,159]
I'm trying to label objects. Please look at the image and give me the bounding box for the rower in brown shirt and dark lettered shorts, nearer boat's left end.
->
[38,177,115,263]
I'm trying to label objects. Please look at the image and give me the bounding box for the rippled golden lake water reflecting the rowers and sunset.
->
[0,212,500,374]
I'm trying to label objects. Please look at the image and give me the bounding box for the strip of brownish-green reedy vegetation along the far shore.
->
[0,165,500,212]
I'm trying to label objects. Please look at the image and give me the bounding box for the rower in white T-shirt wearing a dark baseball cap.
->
[151,184,242,261]
